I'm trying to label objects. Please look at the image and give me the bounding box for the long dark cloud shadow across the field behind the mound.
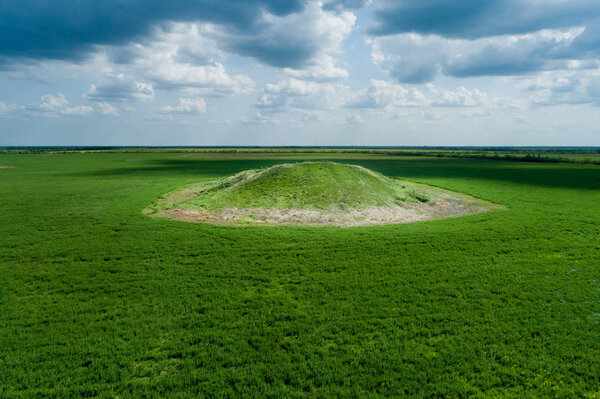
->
[73,158,600,190]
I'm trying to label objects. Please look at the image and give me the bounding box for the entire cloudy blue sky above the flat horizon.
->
[0,0,600,146]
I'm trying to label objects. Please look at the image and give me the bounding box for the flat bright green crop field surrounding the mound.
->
[0,152,600,398]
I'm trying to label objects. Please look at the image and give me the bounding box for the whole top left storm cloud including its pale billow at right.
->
[0,0,356,74]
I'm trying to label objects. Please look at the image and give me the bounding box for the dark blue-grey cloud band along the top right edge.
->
[370,0,600,39]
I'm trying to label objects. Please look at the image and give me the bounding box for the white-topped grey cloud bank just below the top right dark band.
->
[372,28,585,83]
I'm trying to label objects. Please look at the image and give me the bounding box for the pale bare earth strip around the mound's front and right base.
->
[144,183,502,227]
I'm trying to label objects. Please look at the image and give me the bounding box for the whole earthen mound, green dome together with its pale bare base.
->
[145,162,489,226]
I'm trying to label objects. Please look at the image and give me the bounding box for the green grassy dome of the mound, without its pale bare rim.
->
[166,162,429,210]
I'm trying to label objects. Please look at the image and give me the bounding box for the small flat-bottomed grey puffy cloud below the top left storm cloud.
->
[85,74,154,102]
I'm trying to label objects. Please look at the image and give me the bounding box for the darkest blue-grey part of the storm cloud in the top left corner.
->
[0,0,305,63]
